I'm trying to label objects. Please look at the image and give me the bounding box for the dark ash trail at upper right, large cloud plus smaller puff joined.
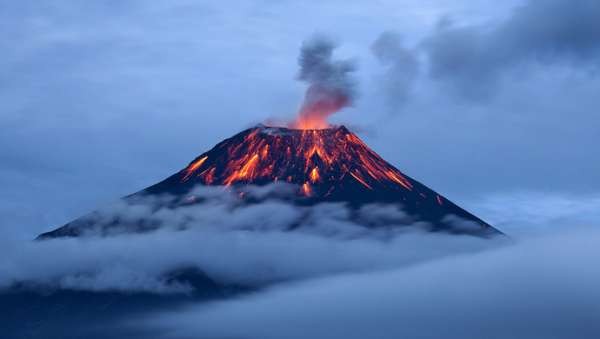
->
[372,0,600,102]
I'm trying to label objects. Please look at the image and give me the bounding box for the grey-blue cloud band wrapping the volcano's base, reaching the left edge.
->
[0,187,506,293]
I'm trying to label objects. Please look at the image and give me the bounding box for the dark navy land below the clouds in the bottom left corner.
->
[0,268,247,339]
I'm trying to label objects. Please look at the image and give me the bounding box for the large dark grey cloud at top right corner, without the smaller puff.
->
[422,0,600,99]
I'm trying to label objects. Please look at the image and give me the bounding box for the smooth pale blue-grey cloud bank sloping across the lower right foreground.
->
[146,228,600,339]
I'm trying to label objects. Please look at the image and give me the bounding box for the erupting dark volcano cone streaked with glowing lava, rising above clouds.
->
[38,125,501,239]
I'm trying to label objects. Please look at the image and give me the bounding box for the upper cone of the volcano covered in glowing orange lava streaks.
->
[181,126,414,196]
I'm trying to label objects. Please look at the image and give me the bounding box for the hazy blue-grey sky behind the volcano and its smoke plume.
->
[0,0,600,237]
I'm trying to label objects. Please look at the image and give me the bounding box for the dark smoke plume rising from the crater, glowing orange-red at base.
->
[293,36,356,129]
